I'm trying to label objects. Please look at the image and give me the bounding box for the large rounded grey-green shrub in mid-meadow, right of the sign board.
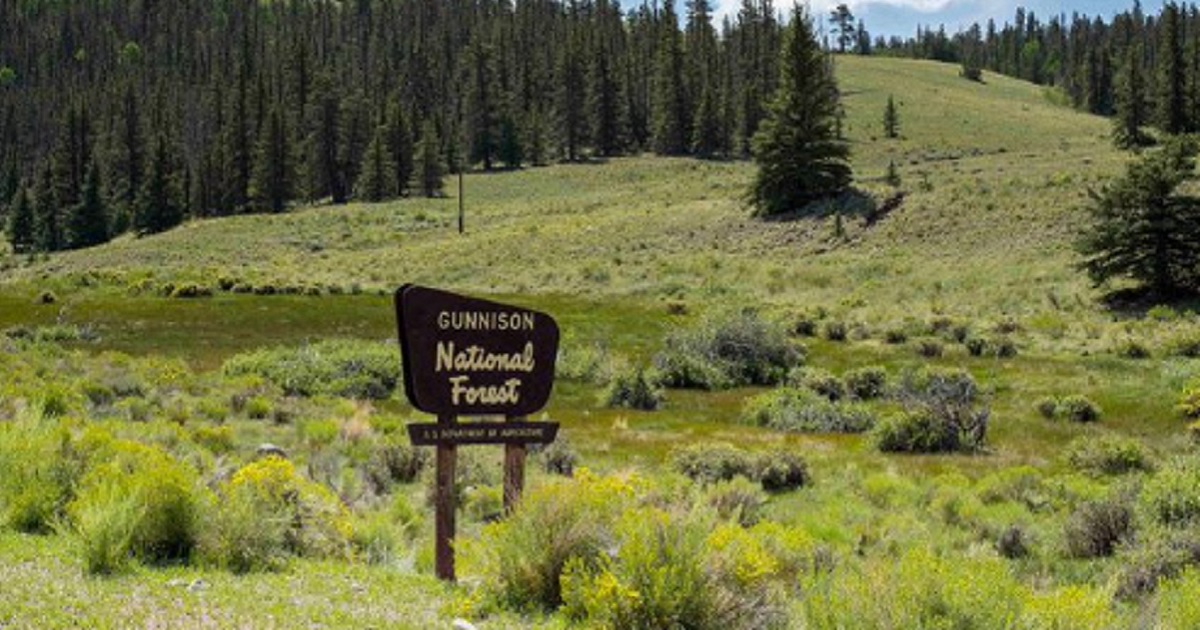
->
[654,311,803,389]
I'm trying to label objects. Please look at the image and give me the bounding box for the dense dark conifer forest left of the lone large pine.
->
[0,0,781,251]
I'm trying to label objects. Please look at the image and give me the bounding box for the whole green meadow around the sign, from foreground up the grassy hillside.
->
[0,56,1200,629]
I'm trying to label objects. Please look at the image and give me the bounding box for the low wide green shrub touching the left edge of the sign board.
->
[223,341,401,400]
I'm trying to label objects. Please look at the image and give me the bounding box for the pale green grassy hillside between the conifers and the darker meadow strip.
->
[0,56,1122,331]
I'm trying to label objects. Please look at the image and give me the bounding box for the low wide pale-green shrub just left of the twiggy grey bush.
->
[742,388,875,433]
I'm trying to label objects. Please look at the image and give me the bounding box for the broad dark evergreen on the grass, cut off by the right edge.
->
[1079,142,1200,298]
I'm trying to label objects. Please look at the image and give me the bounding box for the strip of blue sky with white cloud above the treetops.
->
[714,0,1142,38]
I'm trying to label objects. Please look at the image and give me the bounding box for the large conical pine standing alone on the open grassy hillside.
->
[748,7,851,216]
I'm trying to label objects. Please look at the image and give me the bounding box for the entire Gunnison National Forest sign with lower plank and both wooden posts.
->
[396,284,558,581]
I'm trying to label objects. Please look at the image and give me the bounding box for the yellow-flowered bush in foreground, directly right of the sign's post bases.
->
[462,473,634,611]
